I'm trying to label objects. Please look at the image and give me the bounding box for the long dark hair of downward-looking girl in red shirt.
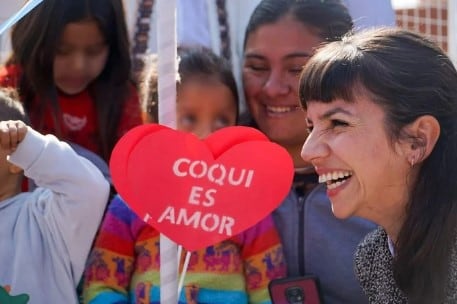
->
[9,0,131,159]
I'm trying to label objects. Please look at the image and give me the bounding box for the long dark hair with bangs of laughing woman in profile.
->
[300,29,457,303]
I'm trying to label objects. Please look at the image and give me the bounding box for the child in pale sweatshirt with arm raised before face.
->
[0,89,109,304]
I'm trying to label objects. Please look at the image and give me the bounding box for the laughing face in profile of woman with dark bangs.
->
[302,97,410,221]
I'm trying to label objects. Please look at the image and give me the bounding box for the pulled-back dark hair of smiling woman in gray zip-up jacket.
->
[243,0,353,46]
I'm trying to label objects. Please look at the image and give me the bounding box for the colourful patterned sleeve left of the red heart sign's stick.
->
[83,196,139,304]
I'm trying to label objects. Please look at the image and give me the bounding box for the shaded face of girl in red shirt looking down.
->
[54,21,109,95]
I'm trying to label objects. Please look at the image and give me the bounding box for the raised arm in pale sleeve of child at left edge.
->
[0,121,109,286]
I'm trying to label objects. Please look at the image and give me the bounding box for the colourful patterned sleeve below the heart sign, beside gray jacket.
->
[241,216,286,304]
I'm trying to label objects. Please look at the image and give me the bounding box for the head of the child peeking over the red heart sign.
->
[141,47,239,134]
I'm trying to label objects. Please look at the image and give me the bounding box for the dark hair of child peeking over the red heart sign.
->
[141,46,239,122]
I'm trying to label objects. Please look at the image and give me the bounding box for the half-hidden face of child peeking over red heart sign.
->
[177,80,236,138]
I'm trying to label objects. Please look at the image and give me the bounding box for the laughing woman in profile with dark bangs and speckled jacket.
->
[300,29,457,304]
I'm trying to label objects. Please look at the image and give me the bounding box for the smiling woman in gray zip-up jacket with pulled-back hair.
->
[243,0,375,304]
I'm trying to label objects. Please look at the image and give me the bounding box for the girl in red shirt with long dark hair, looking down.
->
[0,0,142,161]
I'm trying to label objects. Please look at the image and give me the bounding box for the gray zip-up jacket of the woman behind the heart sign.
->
[273,185,376,304]
